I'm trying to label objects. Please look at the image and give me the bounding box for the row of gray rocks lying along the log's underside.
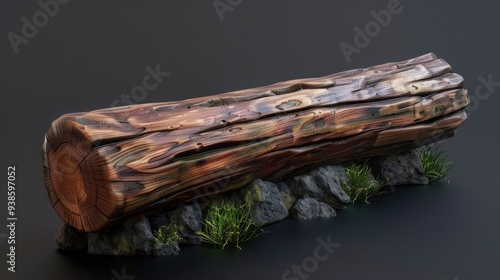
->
[55,151,428,256]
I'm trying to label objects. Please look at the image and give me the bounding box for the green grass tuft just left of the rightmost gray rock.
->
[341,162,383,203]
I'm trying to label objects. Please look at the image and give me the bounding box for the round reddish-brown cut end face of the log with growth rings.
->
[42,116,115,232]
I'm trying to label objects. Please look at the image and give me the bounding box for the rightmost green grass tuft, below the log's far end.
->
[419,145,452,183]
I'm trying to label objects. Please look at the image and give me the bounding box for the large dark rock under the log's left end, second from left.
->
[87,217,155,256]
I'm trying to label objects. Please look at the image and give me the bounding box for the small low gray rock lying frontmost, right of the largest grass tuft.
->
[290,197,337,220]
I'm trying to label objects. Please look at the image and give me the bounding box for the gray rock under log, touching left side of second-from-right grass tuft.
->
[309,165,350,208]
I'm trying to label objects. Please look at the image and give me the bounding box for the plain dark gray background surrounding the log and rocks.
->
[0,0,500,280]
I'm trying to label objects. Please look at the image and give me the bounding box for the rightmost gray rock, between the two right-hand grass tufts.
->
[371,150,429,186]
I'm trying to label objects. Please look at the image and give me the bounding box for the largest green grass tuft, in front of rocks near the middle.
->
[198,201,264,250]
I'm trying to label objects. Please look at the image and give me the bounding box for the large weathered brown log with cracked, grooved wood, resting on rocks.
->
[43,54,469,232]
